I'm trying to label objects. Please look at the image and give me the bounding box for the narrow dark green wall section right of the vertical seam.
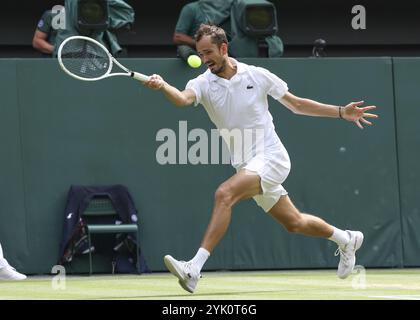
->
[393,58,420,266]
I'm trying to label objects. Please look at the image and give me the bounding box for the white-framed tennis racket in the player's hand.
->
[57,36,149,82]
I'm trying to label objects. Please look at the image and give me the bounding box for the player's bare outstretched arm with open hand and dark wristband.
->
[279,92,378,129]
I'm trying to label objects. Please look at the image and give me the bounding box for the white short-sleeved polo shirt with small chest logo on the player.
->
[186,58,288,167]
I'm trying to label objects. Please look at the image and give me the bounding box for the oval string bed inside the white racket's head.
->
[61,39,110,79]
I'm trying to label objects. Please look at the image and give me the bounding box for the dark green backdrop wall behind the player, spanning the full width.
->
[0,58,420,273]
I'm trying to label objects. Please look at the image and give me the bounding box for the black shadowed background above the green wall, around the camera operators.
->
[0,0,420,57]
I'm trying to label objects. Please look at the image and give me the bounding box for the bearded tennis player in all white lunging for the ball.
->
[144,25,377,293]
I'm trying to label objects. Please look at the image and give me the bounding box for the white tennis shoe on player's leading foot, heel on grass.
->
[163,255,201,293]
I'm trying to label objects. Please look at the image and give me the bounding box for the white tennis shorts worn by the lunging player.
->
[235,142,291,212]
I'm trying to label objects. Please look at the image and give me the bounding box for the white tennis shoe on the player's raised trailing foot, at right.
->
[335,230,363,279]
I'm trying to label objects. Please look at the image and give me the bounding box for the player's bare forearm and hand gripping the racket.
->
[143,74,195,107]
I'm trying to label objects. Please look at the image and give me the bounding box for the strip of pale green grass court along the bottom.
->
[0,269,420,300]
